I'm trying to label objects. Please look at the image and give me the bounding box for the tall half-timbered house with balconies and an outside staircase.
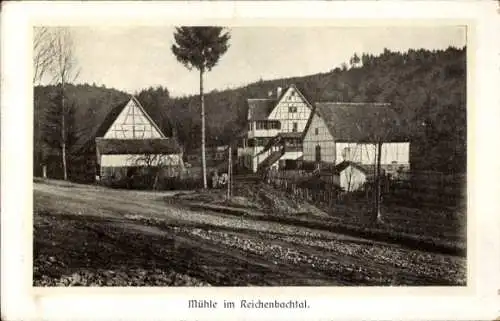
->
[238,85,313,172]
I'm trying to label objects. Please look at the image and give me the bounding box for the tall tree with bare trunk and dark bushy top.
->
[172,27,230,188]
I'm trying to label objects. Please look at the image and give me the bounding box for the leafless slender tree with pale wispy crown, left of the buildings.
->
[50,27,79,180]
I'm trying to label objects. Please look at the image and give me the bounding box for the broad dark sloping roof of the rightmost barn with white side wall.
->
[304,102,409,143]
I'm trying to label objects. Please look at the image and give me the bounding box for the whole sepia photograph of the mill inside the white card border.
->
[32,24,468,287]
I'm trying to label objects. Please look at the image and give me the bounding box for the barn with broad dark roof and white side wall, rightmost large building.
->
[303,102,410,190]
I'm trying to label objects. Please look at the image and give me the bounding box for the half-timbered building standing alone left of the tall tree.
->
[95,97,183,181]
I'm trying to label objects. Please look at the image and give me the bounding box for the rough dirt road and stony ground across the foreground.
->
[34,182,466,286]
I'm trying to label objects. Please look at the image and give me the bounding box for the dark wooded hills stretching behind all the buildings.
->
[34,48,467,175]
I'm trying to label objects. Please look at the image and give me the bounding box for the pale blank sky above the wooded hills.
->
[48,26,466,96]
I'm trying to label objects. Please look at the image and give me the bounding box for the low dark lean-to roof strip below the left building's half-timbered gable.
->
[95,137,181,154]
